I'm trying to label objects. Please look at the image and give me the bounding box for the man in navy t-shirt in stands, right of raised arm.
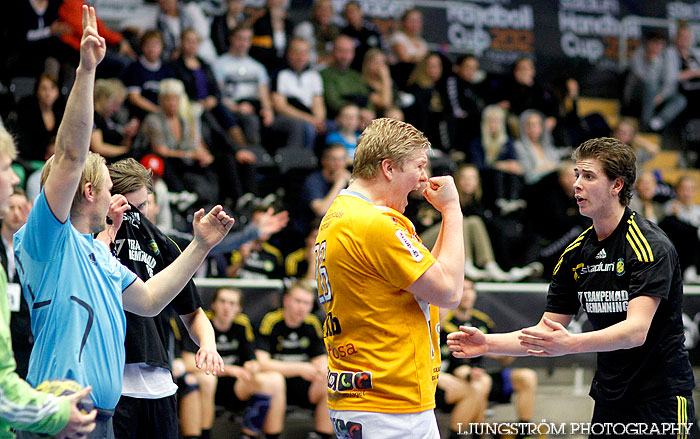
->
[124,30,175,119]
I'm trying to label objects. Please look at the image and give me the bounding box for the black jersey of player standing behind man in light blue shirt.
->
[114,205,202,368]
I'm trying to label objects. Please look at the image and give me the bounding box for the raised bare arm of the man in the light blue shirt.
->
[44,6,107,222]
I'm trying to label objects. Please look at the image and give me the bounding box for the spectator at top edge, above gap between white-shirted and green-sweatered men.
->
[294,0,340,67]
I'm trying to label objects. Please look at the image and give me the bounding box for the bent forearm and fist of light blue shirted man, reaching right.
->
[123,206,233,317]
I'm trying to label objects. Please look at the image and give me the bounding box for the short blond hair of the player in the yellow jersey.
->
[352,117,430,180]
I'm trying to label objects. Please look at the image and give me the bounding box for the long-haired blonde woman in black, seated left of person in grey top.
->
[469,105,523,206]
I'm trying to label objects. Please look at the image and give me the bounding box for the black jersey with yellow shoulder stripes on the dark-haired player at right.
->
[547,208,694,402]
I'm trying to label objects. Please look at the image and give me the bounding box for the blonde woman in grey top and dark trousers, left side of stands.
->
[141,79,219,204]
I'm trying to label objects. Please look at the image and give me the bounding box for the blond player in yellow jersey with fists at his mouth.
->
[315,118,464,439]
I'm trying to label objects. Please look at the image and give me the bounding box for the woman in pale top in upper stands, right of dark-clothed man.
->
[389,9,428,90]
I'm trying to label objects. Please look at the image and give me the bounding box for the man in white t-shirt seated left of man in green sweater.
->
[272,38,326,149]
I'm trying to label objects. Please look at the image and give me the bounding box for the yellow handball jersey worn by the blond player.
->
[315,190,440,413]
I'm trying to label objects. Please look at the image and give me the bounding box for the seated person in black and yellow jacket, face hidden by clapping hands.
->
[226,205,284,279]
